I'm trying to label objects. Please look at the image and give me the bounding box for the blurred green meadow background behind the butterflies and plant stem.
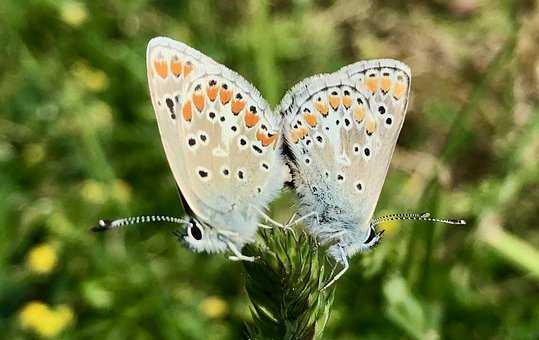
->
[0,0,539,339]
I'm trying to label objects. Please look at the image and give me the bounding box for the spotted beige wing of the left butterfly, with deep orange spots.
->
[143,38,285,244]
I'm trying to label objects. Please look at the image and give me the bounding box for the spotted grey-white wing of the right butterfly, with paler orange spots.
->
[280,59,411,231]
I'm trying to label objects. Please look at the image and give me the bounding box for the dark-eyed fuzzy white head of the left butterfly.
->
[175,217,227,253]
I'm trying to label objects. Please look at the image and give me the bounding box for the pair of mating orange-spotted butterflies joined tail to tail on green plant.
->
[96,38,464,284]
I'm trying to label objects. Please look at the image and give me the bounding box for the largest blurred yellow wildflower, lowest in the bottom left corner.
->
[19,301,73,338]
